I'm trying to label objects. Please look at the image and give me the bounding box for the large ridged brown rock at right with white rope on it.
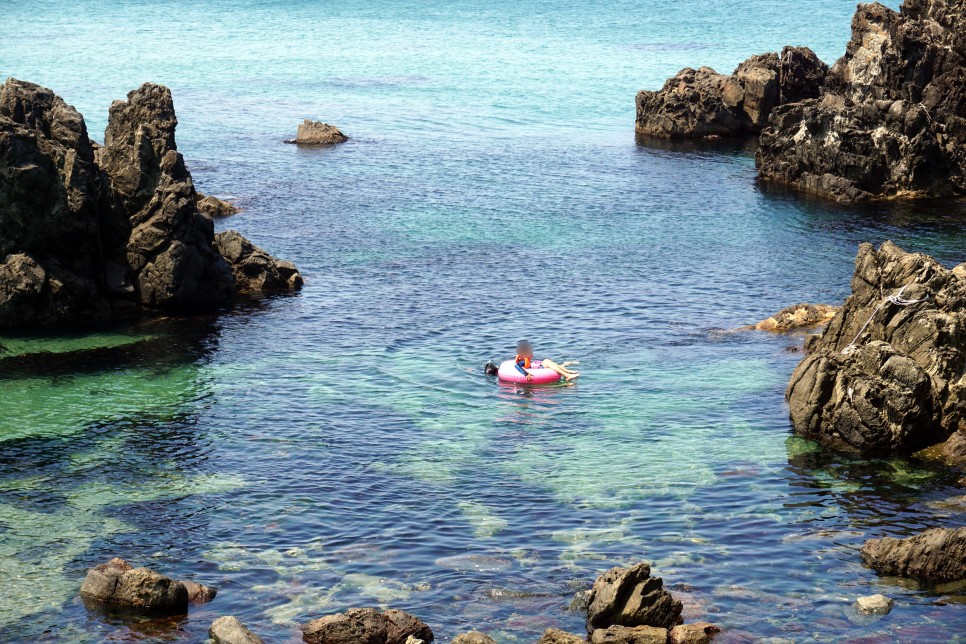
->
[786,242,966,455]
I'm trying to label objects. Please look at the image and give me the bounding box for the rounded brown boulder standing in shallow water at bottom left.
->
[80,559,188,615]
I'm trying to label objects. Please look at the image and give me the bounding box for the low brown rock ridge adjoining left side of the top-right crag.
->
[636,47,828,139]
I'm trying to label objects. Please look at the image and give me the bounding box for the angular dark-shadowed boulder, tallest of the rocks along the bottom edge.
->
[587,563,683,633]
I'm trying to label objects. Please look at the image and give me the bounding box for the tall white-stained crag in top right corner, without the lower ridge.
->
[756,0,966,202]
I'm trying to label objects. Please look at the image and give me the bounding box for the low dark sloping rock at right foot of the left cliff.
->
[214,230,302,295]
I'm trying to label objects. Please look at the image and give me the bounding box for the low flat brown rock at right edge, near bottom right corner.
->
[862,528,966,582]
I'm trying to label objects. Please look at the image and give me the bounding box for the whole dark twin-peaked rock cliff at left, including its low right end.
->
[0,79,301,328]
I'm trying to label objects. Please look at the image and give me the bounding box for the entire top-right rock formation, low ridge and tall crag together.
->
[636,0,966,202]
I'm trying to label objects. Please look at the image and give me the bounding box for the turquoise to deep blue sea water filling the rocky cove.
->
[0,0,966,642]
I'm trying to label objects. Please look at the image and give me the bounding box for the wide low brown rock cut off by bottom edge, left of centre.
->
[302,608,434,644]
